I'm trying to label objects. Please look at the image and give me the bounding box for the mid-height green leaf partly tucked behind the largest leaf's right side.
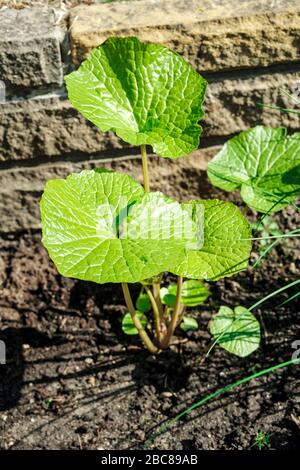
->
[173,199,251,280]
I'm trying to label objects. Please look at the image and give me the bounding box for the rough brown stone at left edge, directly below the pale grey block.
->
[0,94,128,160]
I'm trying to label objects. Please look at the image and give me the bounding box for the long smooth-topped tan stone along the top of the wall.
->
[70,0,300,72]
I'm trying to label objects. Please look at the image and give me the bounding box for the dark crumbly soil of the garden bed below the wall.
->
[0,171,300,450]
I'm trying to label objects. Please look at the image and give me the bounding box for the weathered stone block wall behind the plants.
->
[0,0,300,233]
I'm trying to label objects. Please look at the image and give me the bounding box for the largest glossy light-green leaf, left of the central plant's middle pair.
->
[41,171,193,284]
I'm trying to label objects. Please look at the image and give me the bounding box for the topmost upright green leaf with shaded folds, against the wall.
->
[65,37,207,158]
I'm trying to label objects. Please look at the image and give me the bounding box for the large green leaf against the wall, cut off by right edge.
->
[208,126,300,212]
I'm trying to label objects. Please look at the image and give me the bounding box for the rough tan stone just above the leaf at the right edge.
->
[204,71,300,137]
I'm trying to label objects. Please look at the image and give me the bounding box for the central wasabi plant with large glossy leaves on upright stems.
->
[41,37,252,355]
